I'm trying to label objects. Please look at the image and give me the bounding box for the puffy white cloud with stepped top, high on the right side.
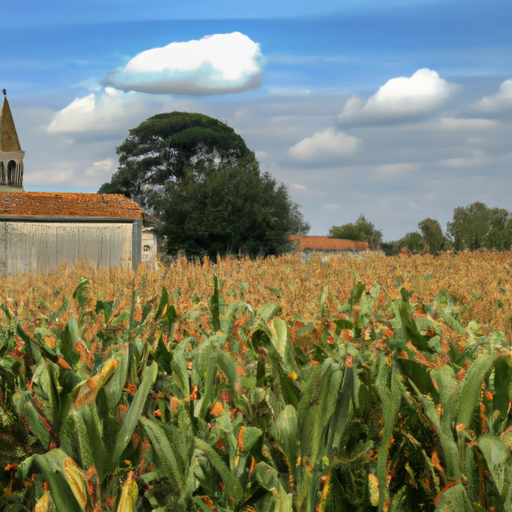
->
[338,68,455,126]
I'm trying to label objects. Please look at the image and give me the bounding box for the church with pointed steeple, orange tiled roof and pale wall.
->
[0,89,150,274]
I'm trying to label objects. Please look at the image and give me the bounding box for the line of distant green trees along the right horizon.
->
[329,202,512,255]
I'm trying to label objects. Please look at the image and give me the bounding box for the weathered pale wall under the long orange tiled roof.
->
[0,220,136,274]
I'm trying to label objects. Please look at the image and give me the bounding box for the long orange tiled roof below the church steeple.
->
[0,192,144,219]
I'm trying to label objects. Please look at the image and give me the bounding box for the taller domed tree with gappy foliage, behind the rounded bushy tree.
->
[98,112,255,213]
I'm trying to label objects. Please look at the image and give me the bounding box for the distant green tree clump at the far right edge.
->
[447,202,512,251]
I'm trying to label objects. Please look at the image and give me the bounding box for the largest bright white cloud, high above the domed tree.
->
[103,32,264,96]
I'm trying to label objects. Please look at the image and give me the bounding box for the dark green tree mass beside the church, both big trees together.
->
[99,112,309,257]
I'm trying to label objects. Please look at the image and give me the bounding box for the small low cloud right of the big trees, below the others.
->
[288,128,360,164]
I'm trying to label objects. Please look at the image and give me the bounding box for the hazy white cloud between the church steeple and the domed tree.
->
[47,87,150,134]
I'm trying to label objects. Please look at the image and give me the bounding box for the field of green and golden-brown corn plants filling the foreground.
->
[0,252,512,512]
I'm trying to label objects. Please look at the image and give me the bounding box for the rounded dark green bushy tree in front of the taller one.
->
[157,161,309,257]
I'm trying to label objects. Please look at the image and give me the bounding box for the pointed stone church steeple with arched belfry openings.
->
[0,89,25,192]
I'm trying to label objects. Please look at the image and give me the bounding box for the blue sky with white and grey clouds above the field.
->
[0,0,512,241]
